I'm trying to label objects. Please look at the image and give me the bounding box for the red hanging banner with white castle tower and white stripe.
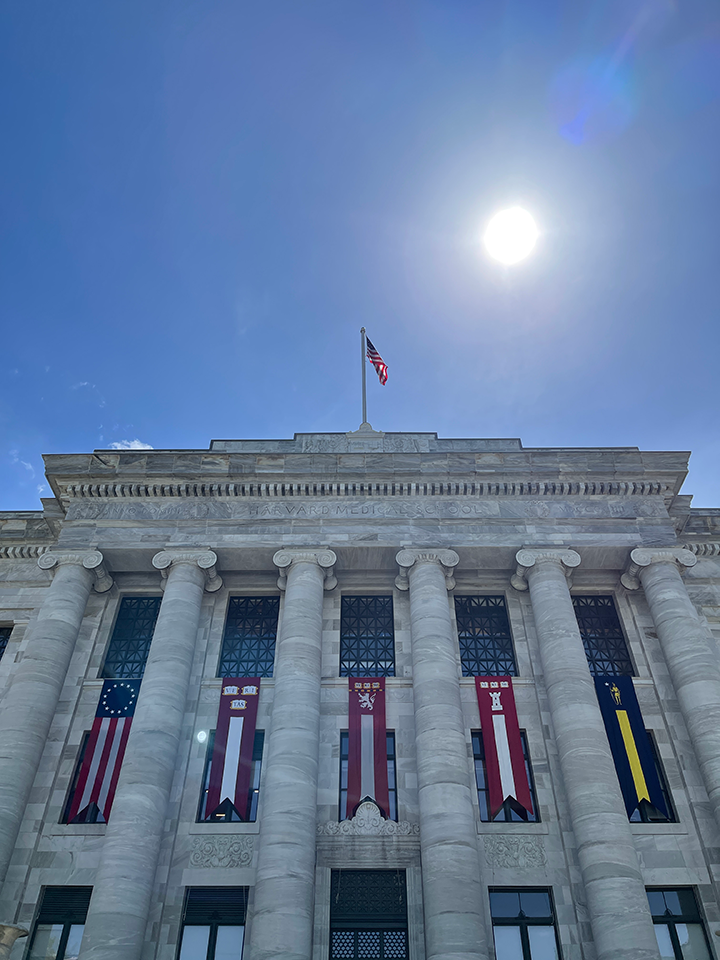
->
[475,677,532,818]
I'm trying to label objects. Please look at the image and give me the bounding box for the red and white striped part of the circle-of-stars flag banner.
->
[68,717,132,822]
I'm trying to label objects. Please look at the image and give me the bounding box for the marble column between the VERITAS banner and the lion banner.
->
[247,548,337,960]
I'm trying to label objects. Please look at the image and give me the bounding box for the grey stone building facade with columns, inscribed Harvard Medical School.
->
[0,433,720,960]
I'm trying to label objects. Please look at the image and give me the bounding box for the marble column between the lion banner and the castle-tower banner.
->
[395,549,489,960]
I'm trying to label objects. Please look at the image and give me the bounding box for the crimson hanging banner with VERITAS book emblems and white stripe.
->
[205,677,260,820]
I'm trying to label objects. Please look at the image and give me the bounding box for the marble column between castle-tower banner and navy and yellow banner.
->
[512,548,659,960]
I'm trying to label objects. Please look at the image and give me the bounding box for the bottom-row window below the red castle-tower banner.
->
[490,887,560,960]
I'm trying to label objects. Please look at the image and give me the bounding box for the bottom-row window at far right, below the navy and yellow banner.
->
[647,887,711,960]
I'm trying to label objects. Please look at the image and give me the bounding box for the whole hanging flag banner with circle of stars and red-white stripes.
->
[68,680,140,823]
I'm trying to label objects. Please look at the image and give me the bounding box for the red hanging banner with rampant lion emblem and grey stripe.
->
[347,677,390,819]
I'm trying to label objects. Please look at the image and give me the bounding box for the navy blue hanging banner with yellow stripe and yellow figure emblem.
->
[595,677,668,817]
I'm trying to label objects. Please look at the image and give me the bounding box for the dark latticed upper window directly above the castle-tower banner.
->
[455,597,517,677]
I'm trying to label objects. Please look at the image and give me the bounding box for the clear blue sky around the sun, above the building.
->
[0,0,720,509]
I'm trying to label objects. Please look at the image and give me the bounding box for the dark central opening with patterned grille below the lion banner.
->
[330,870,408,960]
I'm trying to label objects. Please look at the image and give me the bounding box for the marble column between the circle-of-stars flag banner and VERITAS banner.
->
[80,548,222,960]
